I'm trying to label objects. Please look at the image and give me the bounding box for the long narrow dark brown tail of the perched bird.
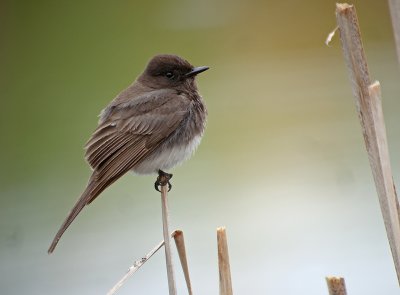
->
[47,172,103,254]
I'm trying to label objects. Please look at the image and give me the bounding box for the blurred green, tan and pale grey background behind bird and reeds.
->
[0,0,400,295]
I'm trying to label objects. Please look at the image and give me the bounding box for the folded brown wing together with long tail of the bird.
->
[48,90,191,253]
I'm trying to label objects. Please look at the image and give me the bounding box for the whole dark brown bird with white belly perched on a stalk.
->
[48,55,208,253]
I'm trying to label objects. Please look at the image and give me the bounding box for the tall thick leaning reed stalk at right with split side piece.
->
[336,4,400,283]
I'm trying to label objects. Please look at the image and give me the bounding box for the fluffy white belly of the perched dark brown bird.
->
[132,135,201,174]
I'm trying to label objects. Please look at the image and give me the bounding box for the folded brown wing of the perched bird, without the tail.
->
[82,90,190,203]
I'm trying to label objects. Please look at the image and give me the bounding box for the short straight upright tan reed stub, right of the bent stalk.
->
[217,227,233,295]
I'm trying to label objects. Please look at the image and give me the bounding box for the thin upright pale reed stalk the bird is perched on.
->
[161,185,176,295]
